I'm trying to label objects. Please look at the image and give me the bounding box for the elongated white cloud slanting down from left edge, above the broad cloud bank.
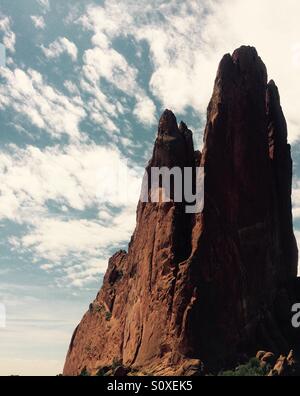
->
[0,68,86,139]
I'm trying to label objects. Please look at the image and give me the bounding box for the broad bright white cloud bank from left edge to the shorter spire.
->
[0,144,142,223]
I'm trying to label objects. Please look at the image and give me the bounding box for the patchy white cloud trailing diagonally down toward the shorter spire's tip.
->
[79,4,156,126]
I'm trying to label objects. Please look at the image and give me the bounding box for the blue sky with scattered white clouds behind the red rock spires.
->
[0,0,300,375]
